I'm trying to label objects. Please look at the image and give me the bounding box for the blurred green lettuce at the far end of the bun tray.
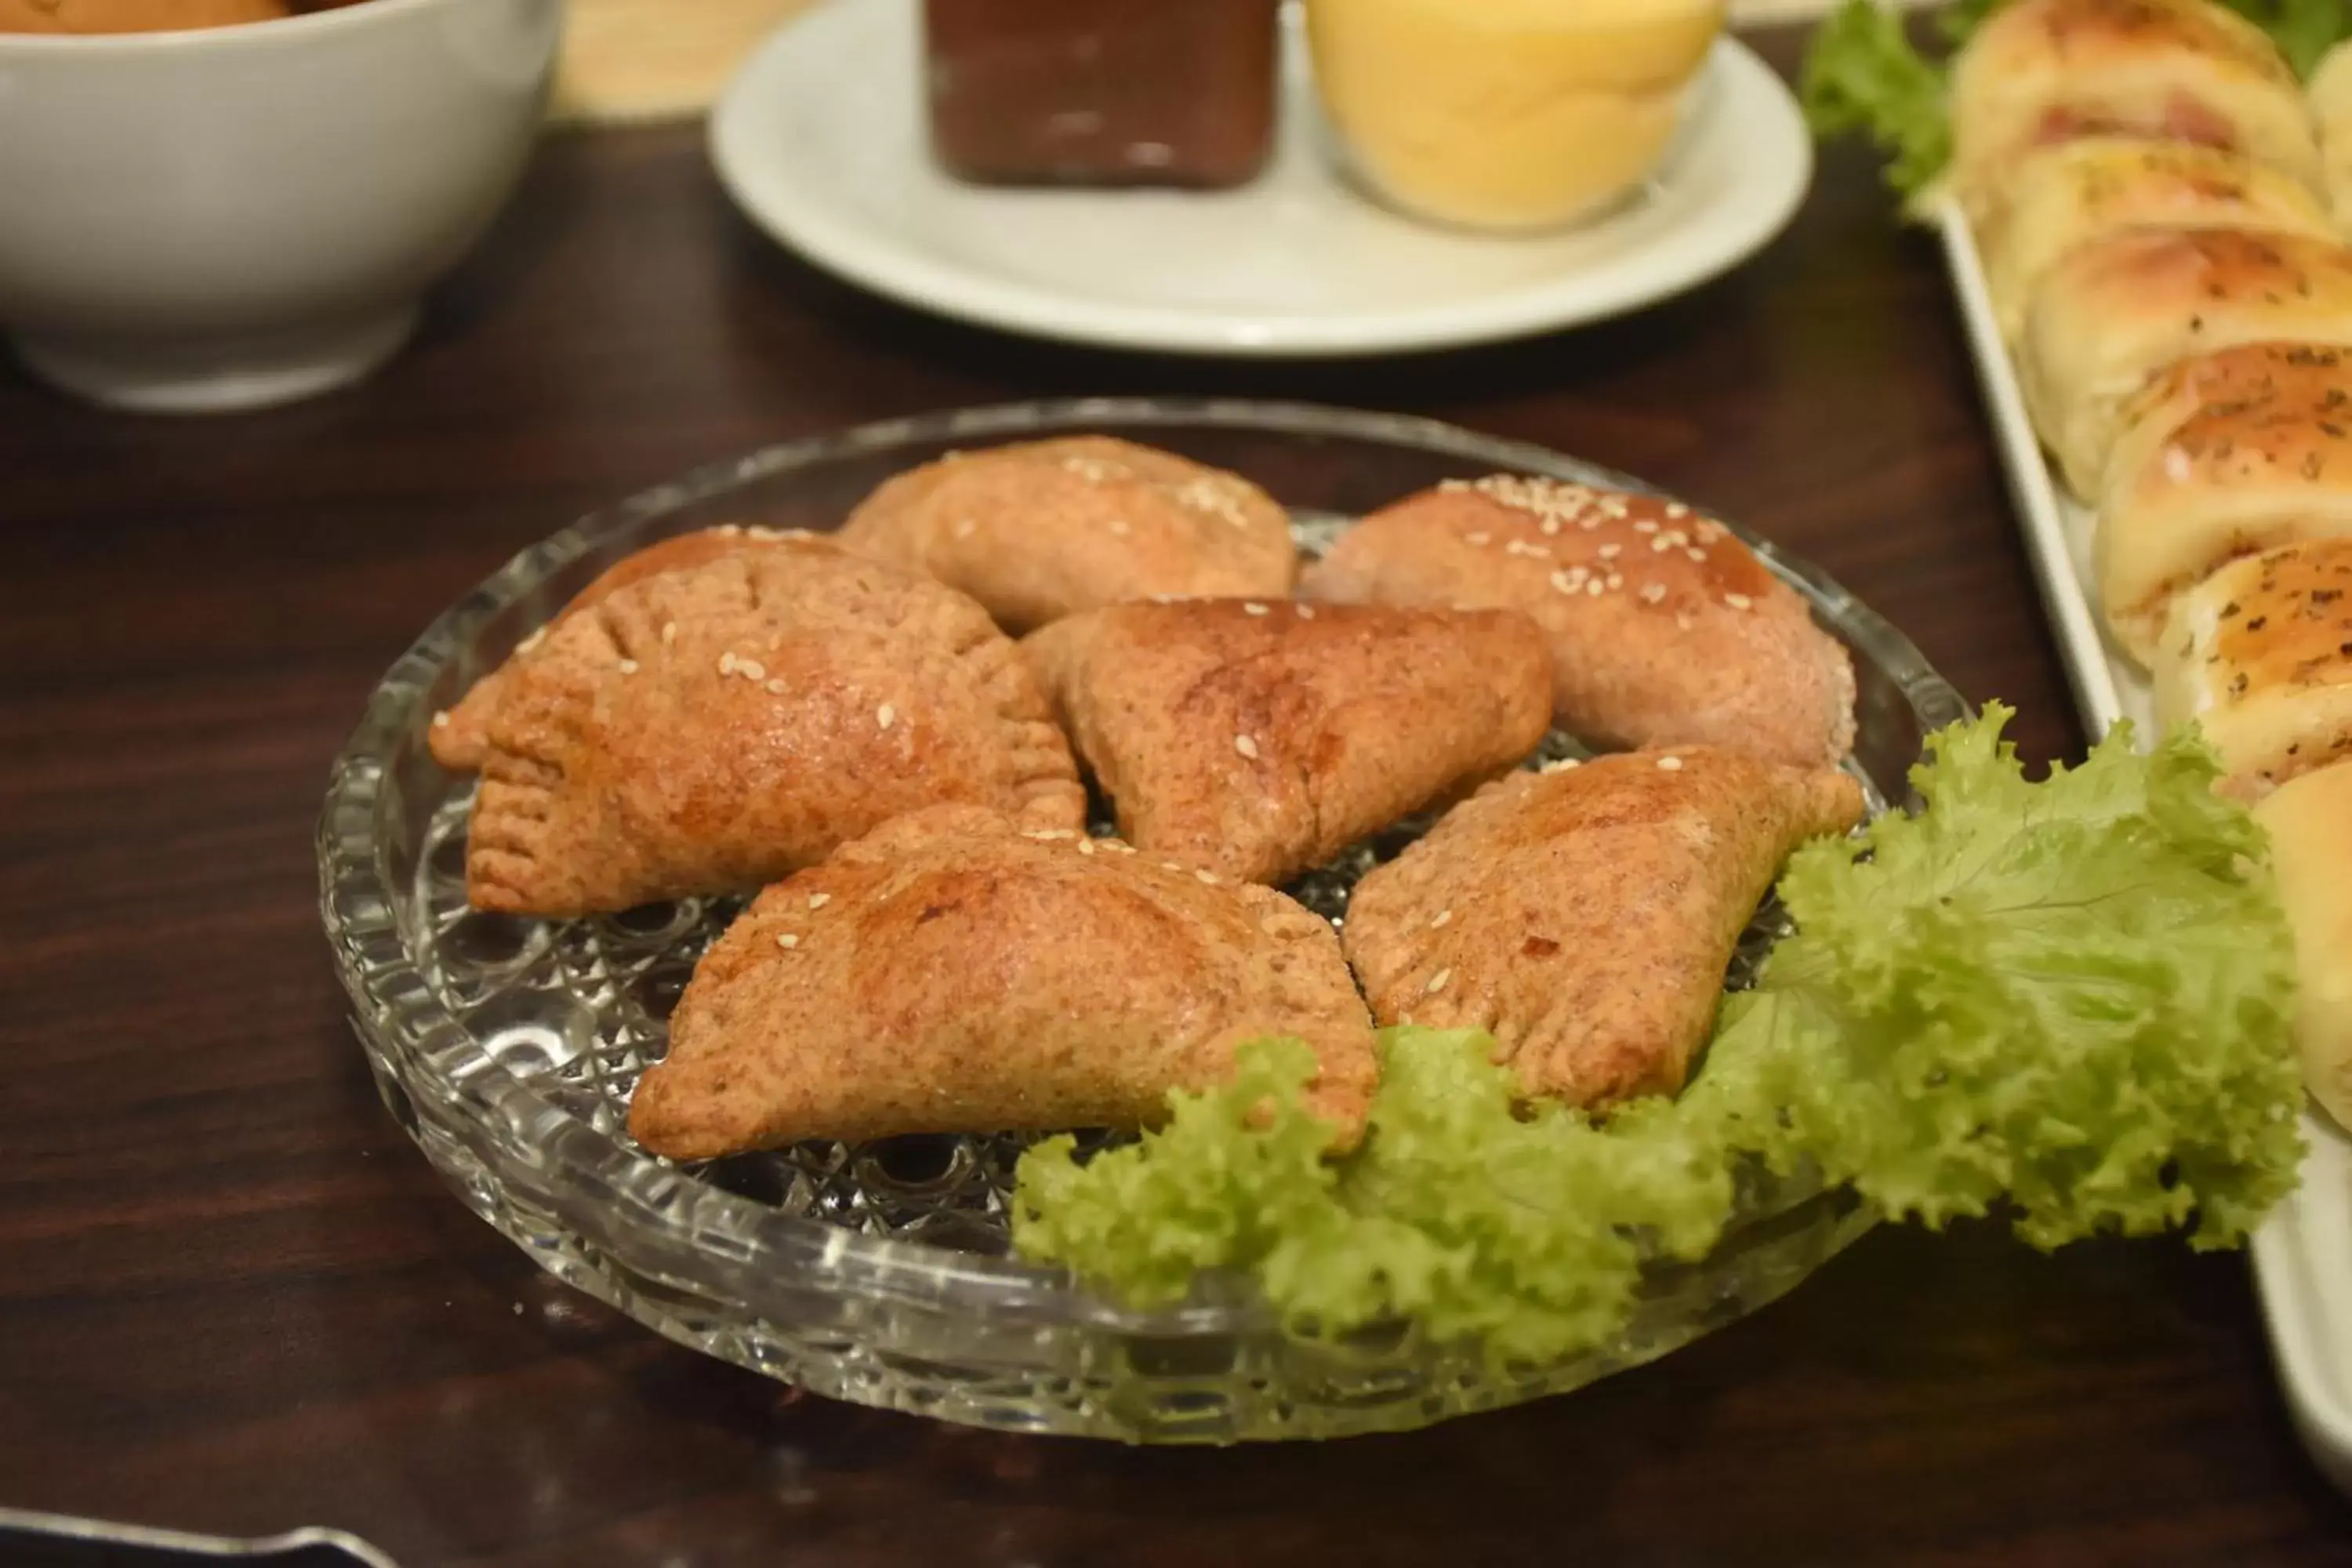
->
[1799,0,2352,209]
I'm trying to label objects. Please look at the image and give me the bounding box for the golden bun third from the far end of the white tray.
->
[2018,228,2352,499]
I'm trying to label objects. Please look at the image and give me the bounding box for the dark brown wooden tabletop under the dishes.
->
[0,24,2352,1568]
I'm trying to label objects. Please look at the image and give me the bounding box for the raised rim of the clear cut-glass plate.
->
[318,397,1969,1338]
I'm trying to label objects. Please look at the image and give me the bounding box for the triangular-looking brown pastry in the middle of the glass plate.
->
[1021,600,1552,884]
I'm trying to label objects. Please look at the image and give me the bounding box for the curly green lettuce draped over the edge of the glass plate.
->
[1014,708,2300,1361]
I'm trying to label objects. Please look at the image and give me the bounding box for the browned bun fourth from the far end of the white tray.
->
[2093,343,2352,666]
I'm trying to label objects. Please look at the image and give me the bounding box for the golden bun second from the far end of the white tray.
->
[1976,136,2336,341]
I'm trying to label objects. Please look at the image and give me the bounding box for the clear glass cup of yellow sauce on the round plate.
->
[1305,0,1726,230]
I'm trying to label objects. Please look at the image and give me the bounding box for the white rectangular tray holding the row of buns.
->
[1938,207,2352,1490]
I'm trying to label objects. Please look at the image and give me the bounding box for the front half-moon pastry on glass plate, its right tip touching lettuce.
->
[628,806,1378,1159]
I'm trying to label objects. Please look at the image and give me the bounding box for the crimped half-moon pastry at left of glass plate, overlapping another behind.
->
[466,539,1087,916]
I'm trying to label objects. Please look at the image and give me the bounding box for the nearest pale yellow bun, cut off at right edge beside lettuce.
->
[2253,764,2352,1128]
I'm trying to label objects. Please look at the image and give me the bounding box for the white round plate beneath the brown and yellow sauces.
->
[710,0,1813,358]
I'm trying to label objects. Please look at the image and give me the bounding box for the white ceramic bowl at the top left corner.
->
[0,0,562,414]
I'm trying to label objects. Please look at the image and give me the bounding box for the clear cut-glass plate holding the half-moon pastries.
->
[318,400,1964,1441]
